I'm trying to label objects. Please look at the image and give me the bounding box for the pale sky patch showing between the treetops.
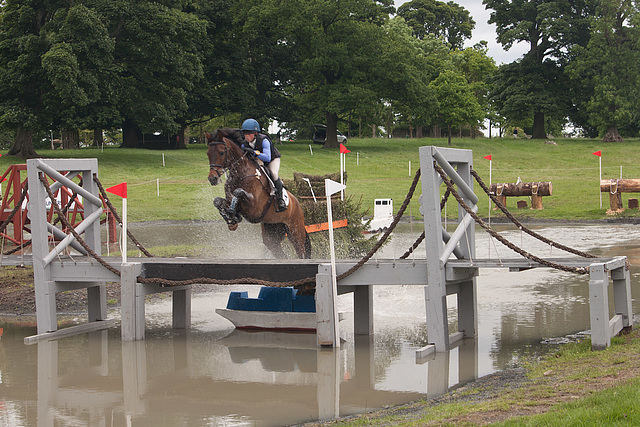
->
[395,0,528,65]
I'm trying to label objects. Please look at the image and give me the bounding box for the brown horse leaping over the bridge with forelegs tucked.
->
[205,128,311,258]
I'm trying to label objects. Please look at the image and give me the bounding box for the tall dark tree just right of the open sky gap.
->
[482,0,592,138]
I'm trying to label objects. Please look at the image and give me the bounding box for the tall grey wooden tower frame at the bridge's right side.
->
[420,146,478,352]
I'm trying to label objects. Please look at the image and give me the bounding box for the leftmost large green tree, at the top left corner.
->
[0,0,113,158]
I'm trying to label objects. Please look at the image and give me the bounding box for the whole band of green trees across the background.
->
[0,0,640,157]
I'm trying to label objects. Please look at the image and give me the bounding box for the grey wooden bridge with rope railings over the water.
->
[8,147,633,357]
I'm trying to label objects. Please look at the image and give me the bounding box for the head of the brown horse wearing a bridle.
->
[204,129,242,185]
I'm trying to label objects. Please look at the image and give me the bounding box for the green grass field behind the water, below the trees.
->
[0,138,640,222]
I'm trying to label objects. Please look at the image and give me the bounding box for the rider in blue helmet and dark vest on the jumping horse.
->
[242,119,287,212]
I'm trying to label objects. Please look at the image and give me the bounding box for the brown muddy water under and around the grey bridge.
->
[0,223,640,426]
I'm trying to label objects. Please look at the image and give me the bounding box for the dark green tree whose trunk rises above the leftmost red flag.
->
[102,0,205,147]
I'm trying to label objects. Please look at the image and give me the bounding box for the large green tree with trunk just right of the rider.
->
[264,0,393,148]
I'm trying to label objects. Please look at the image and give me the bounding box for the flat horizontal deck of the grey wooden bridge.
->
[0,255,624,286]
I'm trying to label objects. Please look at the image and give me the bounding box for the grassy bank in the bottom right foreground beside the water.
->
[311,330,640,427]
